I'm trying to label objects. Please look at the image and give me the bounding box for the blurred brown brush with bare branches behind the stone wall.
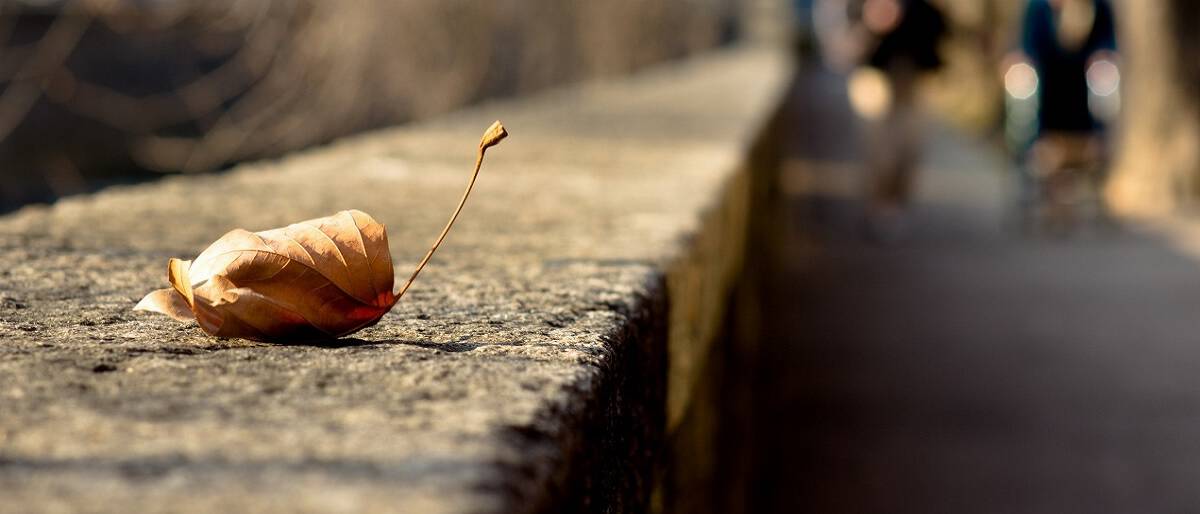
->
[0,0,737,207]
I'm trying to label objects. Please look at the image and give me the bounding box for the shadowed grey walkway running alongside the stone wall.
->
[750,69,1200,513]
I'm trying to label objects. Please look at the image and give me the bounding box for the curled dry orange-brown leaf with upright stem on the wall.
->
[134,121,508,341]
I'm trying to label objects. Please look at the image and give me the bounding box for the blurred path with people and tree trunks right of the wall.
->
[720,0,1200,513]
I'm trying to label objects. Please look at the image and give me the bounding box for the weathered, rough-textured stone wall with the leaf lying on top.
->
[0,46,788,512]
